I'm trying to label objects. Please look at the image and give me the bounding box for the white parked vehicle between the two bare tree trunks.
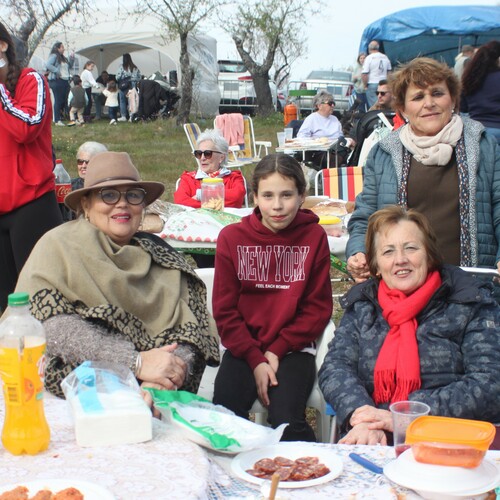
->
[218,60,277,114]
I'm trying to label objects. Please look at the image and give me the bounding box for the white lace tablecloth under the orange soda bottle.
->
[0,395,210,500]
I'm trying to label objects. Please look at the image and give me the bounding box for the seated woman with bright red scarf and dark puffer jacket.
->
[319,205,500,444]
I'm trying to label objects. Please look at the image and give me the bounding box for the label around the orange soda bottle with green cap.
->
[0,337,46,406]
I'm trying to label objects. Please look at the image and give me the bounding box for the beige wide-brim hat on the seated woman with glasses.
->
[64,151,165,212]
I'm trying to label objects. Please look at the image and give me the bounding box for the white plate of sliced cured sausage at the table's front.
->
[231,442,343,488]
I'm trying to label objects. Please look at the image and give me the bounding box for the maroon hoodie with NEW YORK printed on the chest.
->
[213,208,332,370]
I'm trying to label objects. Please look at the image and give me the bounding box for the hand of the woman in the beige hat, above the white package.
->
[136,344,187,390]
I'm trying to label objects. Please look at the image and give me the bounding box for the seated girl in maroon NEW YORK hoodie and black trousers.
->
[213,154,332,441]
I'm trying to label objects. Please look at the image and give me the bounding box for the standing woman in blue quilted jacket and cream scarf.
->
[346,58,500,281]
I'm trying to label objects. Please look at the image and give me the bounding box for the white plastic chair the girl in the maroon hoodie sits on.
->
[196,268,336,443]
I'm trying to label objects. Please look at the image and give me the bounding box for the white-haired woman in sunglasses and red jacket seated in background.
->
[174,130,246,208]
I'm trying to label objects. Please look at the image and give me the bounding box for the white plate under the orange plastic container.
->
[384,449,500,498]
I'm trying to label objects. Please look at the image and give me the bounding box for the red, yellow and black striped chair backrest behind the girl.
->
[315,167,363,201]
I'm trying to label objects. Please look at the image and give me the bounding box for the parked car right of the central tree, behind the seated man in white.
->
[288,70,354,115]
